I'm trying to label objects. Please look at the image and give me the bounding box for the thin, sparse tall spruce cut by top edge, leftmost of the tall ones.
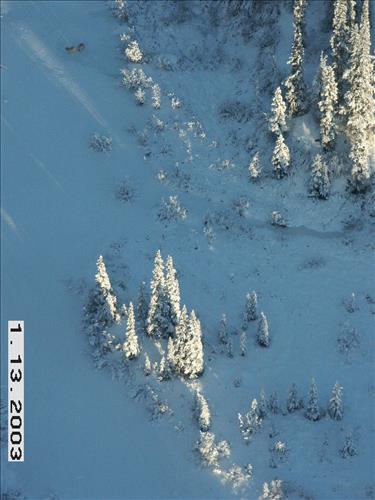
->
[284,0,307,117]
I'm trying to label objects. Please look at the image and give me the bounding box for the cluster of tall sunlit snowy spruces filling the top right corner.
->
[268,0,375,193]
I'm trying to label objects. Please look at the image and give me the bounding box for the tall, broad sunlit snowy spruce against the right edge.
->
[343,0,375,192]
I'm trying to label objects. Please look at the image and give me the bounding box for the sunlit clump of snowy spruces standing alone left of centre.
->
[86,251,204,380]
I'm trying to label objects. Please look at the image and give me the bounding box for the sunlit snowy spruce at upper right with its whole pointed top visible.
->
[318,53,338,151]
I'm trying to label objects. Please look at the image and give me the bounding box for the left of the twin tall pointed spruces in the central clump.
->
[147,250,170,338]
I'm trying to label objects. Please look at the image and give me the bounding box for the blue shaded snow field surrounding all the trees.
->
[1,0,375,500]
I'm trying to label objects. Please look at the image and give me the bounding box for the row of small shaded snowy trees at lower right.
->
[238,379,344,443]
